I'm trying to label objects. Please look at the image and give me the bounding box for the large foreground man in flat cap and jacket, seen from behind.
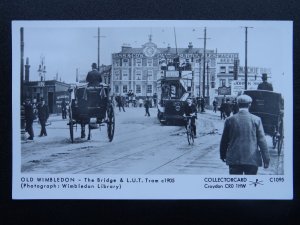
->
[220,95,270,175]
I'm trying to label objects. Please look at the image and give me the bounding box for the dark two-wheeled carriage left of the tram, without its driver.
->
[68,84,115,143]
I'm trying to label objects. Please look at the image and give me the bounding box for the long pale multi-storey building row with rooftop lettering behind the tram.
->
[110,36,270,103]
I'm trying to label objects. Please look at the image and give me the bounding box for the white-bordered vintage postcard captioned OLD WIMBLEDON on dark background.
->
[12,20,293,199]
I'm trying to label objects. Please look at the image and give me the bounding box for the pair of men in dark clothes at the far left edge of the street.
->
[24,98,49,140]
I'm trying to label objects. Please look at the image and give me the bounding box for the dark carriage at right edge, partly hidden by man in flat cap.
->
[244,90,284,155]
